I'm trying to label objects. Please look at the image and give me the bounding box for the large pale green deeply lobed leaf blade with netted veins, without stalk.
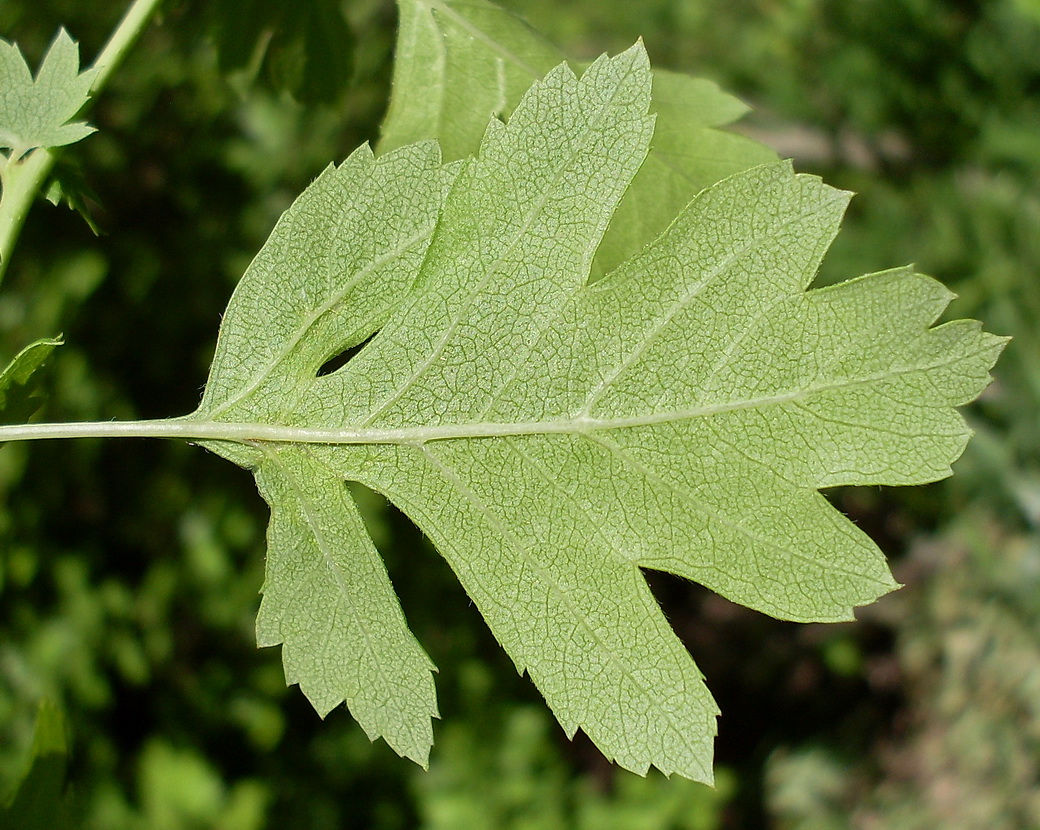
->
[189,44,1004,781]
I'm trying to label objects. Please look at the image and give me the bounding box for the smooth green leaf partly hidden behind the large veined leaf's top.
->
[380,0,776,279]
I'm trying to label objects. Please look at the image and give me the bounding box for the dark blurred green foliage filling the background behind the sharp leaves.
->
[0,0,1040,830]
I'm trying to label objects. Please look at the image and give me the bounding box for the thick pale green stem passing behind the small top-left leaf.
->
[0,0,161,281]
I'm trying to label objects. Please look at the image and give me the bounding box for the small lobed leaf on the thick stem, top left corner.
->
[0,29,96,159]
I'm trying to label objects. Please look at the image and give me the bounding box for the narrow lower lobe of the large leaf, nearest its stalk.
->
[257,447,437,767]
